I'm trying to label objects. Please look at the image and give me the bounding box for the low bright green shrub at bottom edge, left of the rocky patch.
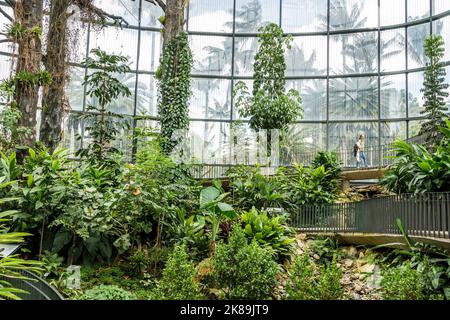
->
[286,253,344,300]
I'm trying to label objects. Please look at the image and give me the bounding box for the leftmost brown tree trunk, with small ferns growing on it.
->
[14,0,43,146]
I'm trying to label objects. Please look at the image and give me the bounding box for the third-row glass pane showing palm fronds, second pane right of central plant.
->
[329,77,378,120]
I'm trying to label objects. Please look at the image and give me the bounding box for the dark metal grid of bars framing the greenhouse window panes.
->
[0,0,450,159]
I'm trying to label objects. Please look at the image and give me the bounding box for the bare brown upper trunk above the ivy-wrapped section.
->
[163,0,186,47]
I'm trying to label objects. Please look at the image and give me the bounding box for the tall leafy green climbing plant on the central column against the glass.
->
[234,23,303,130]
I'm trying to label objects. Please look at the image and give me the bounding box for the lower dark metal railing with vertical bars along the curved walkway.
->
[290,192,450,239]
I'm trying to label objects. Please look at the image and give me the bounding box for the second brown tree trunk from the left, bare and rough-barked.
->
[40,0,71,151]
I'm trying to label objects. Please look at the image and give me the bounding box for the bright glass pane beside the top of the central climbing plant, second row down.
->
[286,36,327,76]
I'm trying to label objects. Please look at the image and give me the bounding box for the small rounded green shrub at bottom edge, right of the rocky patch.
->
[381,263,425,300]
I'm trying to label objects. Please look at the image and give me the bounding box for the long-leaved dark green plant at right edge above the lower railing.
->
[381,125,450,193]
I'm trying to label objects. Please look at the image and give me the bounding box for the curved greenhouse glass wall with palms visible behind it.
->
[0,0,450,163]
